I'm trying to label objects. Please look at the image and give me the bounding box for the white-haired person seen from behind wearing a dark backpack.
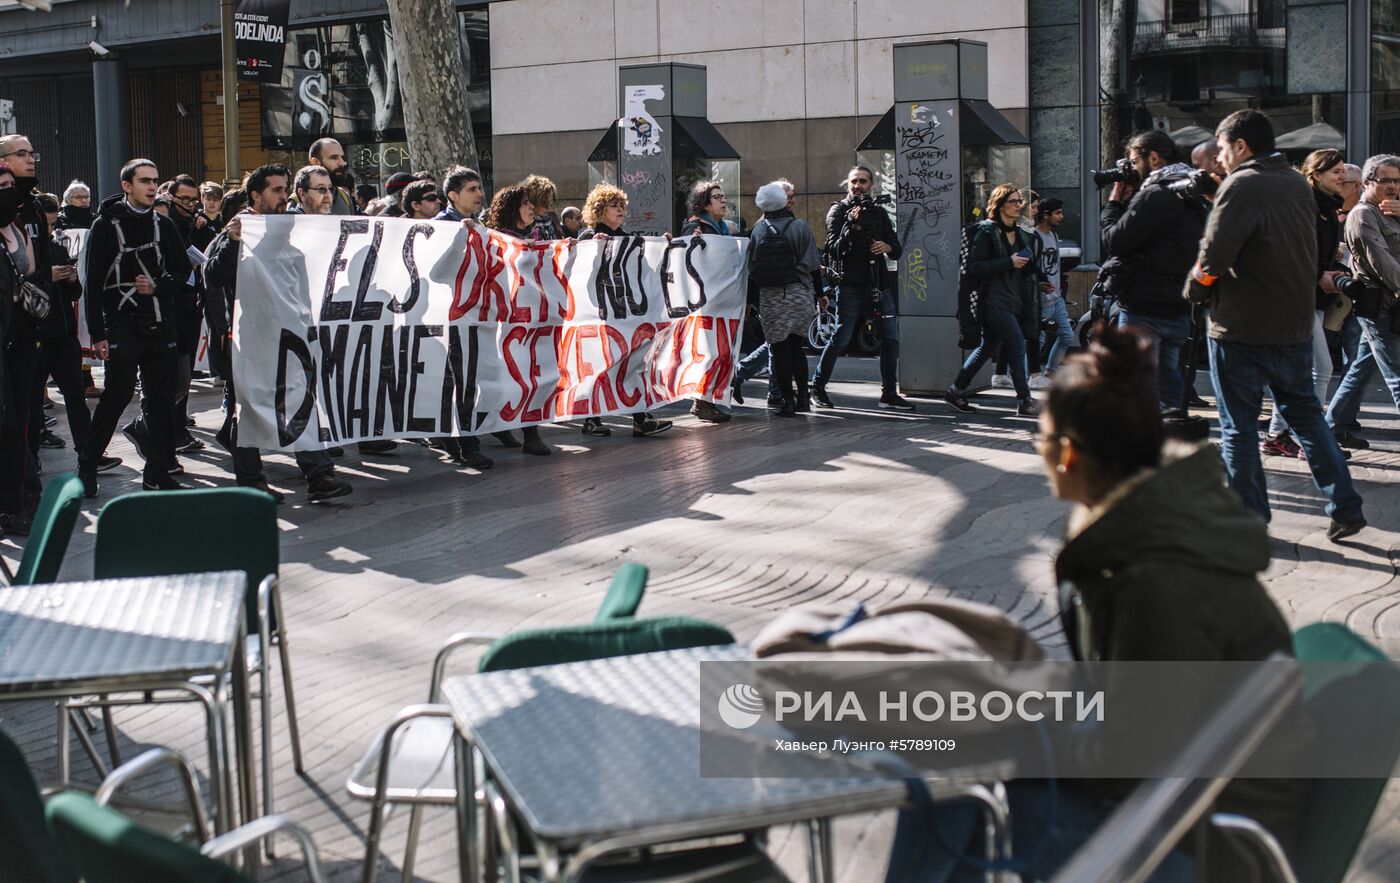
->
[749,181,822,417]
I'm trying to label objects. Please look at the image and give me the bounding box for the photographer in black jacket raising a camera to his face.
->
[1096,132,1205,410]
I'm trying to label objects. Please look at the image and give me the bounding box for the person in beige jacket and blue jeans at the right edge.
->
[1327,154,1400,448]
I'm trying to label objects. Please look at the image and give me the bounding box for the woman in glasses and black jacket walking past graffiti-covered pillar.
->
[944,183,1042,417]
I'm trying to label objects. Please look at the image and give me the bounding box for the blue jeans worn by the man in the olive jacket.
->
[1211,339,1361,522]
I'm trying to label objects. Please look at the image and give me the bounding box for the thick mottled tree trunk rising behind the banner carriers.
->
[389,0,479,181]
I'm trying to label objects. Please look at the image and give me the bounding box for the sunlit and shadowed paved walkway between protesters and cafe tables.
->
[0,372,1400,883]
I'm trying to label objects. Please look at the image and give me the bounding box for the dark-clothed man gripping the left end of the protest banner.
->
[203,165,351,502]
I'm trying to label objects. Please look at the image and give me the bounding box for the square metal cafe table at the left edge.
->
[0,571,255,855]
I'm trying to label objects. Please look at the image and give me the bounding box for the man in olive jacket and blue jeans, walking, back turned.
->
[1186,111,1366,542]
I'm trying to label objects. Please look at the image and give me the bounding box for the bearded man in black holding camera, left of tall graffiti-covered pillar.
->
[812,165,914,411]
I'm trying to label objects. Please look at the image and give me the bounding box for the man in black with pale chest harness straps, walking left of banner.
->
[78,160,193,497]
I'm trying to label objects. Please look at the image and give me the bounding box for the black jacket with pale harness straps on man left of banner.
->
[83,196,193,341]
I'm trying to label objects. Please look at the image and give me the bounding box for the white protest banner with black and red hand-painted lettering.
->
[234,214,748,451]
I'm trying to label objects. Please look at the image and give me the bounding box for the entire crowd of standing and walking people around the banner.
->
[0,111,1400,539]
